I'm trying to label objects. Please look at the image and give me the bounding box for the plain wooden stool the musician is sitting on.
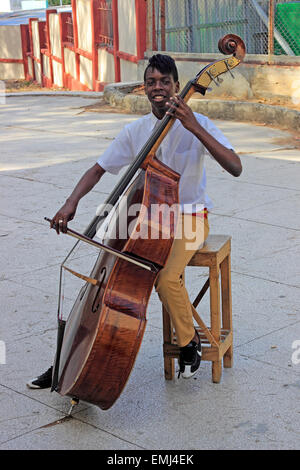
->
[163,235,233,383]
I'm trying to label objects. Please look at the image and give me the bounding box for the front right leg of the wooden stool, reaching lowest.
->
[209,266,222,383]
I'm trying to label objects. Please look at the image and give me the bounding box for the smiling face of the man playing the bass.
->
[145,67,179,119]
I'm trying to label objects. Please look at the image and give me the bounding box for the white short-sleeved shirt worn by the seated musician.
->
[98,113,233,213]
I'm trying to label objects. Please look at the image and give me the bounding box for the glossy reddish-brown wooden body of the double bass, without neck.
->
[56,159,179,410]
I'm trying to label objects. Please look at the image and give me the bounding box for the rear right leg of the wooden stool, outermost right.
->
[221,254,233,367]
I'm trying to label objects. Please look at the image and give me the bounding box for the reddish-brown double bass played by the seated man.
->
[46,34,245,410]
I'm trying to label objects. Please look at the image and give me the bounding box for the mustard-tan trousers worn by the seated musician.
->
[155,214,209,347]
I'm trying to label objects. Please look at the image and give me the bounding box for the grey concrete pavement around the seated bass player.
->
[0,96,300,450]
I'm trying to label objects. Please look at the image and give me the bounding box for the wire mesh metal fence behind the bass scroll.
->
[148,0,300,55]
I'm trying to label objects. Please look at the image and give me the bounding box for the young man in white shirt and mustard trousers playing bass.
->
[27,54,242,388]
